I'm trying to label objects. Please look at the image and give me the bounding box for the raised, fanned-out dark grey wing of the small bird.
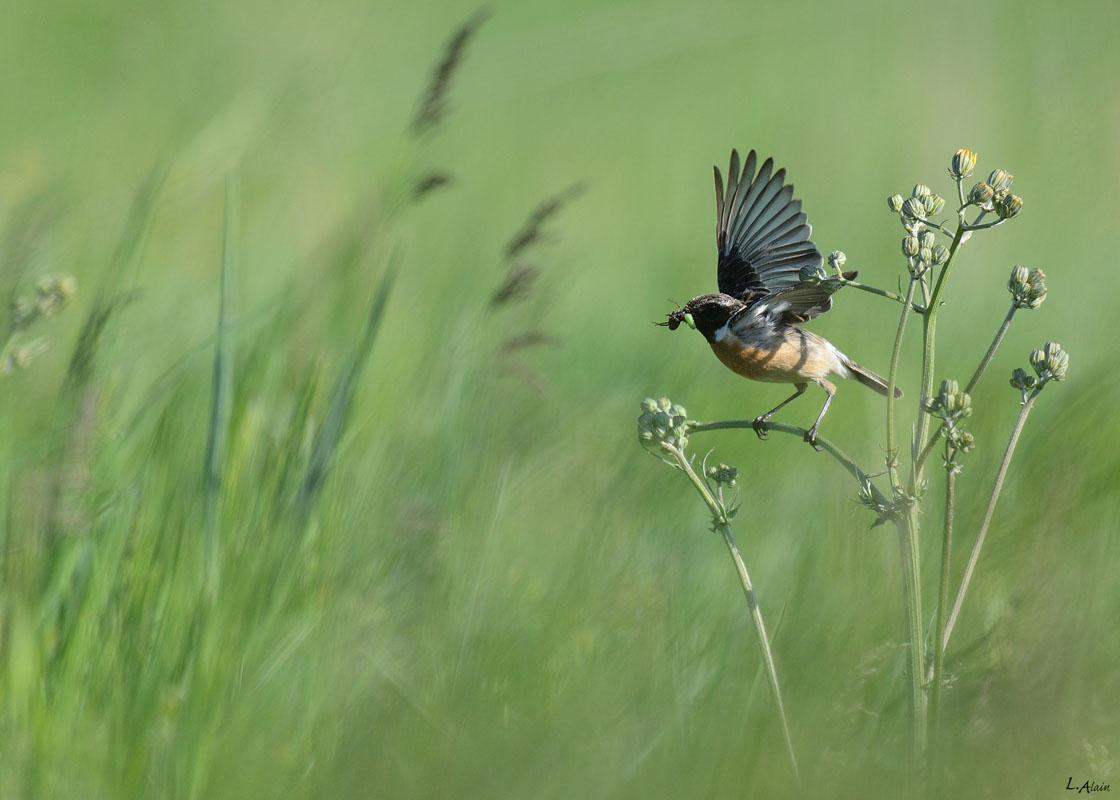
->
[716,150,831,302]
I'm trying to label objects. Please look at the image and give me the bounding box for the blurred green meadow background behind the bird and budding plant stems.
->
[0,0,1120,798]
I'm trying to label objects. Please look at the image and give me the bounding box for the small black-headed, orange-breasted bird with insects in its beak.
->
[657,150,903,449]
